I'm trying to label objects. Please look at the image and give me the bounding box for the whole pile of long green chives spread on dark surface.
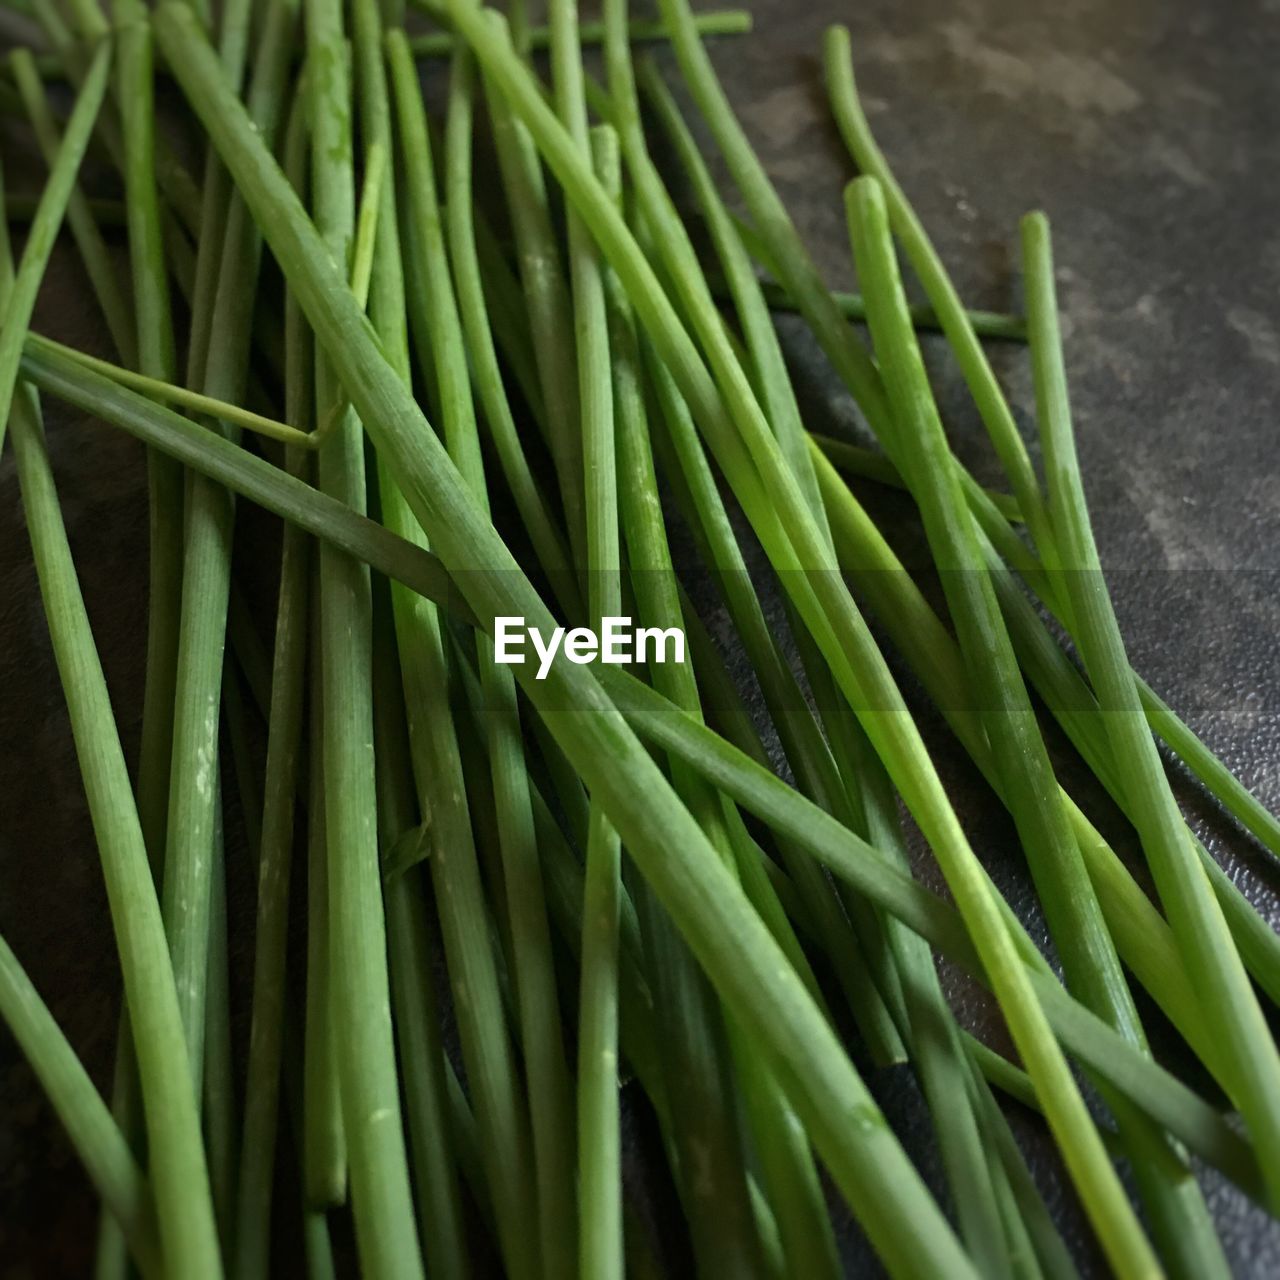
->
[0,0,1280,1280]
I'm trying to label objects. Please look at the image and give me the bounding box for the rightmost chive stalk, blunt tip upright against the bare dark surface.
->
[1023,214,1280,1206]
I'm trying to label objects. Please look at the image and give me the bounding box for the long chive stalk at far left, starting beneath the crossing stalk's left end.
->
[13,393,221,1277]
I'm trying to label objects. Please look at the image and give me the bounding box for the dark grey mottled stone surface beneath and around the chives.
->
[0,0,1280,1277]
